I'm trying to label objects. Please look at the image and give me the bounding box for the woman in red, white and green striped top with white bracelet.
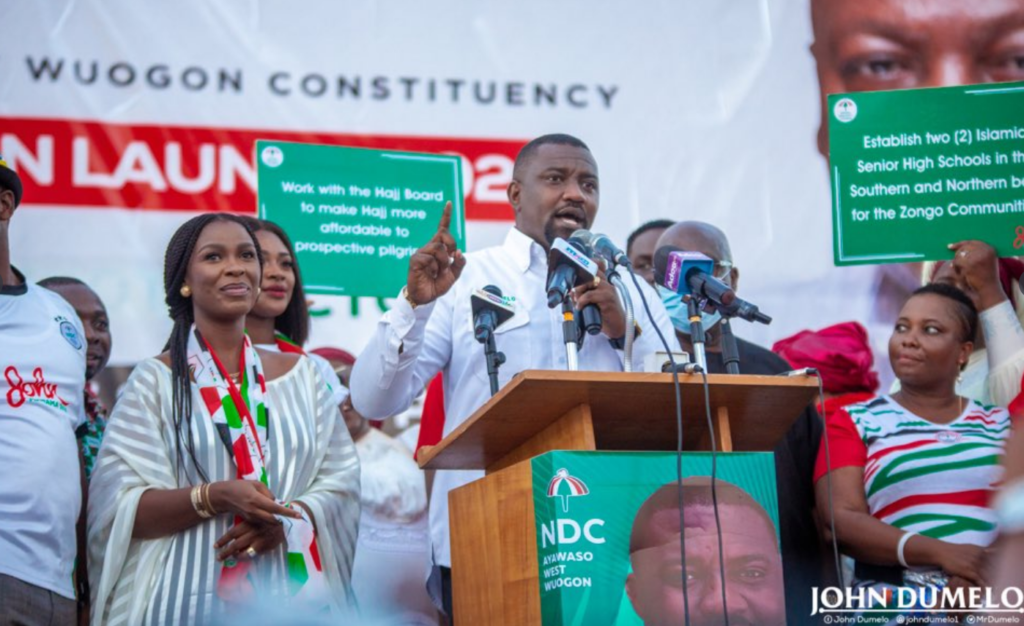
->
[814,285,1010,606]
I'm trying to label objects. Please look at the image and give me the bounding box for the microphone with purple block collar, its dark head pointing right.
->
[654,246,771,324]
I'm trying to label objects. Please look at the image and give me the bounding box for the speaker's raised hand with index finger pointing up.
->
[406,202,466,305]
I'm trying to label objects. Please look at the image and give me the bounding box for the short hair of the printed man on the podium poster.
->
[630,476,778,554]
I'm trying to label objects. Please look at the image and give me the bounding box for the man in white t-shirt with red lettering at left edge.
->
[0,158,86,626]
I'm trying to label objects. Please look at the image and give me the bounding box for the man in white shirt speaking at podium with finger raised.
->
[351,134,679,616]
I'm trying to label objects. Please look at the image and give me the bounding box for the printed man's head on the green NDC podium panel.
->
[626,476,786,626]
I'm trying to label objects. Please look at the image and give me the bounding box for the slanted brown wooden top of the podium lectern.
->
[419,370,818,469]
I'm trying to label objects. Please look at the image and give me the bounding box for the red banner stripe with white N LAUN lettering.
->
[0,117,525,220]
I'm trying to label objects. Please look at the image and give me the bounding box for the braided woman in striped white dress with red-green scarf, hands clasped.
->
[88,214,359,625]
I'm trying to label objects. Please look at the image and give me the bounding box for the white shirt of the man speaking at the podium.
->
[351,228,679,567]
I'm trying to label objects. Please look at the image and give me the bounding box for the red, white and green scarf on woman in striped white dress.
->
[188,325,328,609]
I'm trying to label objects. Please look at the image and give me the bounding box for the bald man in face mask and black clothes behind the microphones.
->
[655,221,831,624]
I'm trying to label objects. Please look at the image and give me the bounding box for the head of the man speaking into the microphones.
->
[509,143,599,248]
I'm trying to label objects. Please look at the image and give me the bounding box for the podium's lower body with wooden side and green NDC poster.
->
[451,452,785,626]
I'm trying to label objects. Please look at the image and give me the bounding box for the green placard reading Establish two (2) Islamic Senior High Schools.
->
[828,83,1024,265]
